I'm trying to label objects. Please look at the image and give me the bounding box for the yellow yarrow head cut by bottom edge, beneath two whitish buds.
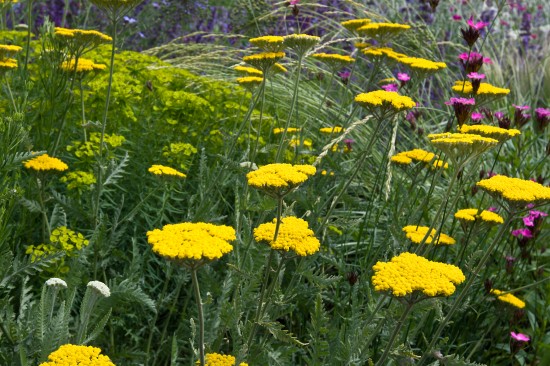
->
[40,344,115,366]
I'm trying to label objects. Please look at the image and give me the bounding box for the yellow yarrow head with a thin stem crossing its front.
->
[254,216,321,257]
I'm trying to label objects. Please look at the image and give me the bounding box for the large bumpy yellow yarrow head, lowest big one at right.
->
[372,252,466,297]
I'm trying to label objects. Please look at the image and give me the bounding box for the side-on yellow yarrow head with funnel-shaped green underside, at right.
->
[428,133,498,166]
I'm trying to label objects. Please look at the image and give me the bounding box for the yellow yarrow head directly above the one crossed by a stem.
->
[246,164,317,197]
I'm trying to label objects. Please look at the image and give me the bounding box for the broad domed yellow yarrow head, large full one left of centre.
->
[147,222,236,267]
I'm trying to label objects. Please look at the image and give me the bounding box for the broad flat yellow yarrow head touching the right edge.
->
[476,175,550,204]
